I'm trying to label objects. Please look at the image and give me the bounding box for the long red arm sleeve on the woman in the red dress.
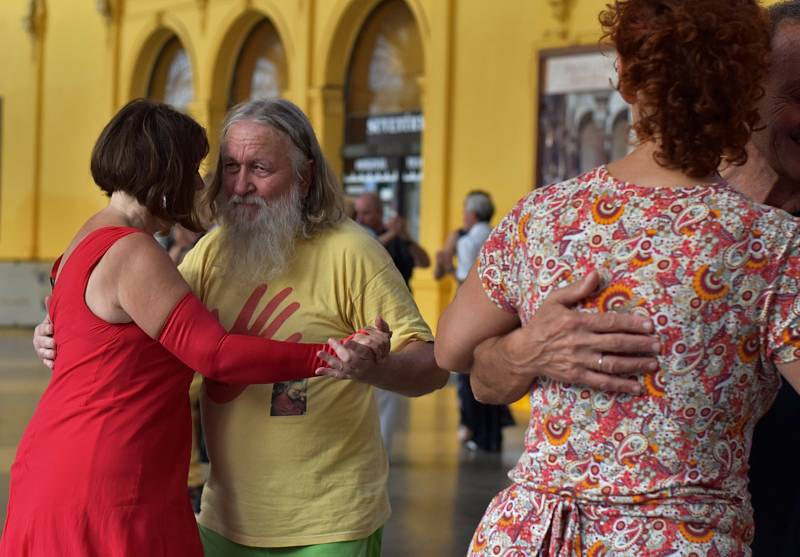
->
[158,292,332,384]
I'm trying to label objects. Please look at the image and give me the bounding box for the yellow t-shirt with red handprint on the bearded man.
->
[180,220,433,547]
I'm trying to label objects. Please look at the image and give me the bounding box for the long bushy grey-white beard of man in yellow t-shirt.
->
[219,186,303,281]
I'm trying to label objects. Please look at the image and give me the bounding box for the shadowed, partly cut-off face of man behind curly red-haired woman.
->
[753,21,800,184]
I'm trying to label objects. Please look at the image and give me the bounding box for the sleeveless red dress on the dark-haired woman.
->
[0,227,328,557]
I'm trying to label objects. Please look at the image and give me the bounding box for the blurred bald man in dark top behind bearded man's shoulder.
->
[354,192,431,458]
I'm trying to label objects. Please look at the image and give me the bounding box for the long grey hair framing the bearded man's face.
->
[206,99,345,238]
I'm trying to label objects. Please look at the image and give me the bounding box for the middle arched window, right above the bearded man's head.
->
[228,18,289,107]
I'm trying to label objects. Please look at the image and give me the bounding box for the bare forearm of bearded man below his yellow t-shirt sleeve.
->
[369,341,449,396]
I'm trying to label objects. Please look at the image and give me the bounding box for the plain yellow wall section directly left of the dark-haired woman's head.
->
[36,1,113,254]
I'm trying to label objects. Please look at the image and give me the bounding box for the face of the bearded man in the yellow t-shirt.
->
[222,120,299,219]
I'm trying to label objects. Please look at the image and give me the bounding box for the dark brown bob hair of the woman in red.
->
[91,99,208,232]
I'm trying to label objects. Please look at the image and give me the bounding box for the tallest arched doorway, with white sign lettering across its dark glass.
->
[342,0,424,239]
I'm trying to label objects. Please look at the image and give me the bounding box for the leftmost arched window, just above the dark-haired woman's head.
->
[147,35,194,112]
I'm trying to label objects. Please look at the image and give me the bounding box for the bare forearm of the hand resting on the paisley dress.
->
[470,335,533,404]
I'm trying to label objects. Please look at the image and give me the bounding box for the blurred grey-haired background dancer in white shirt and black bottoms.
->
[434,190,514,452]
